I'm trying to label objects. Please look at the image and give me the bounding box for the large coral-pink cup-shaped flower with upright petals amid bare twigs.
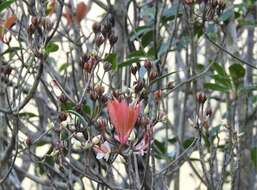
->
[107,99,140,144]
